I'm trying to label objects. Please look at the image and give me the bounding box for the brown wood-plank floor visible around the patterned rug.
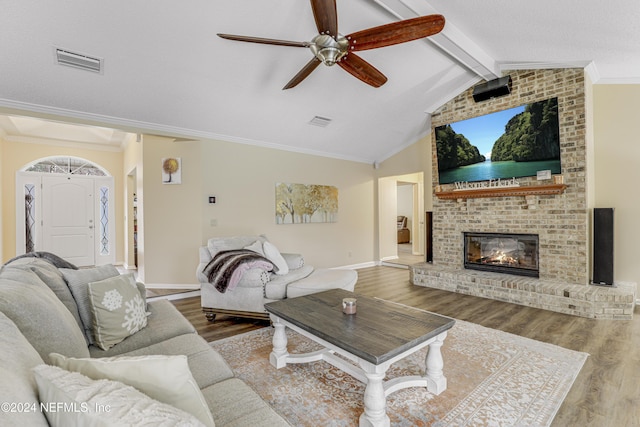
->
[172,267,640,427]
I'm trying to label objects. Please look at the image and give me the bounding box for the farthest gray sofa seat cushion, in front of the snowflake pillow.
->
[89,299,196,357]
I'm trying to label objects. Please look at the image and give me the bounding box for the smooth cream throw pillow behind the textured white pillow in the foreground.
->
[49,353,215,427]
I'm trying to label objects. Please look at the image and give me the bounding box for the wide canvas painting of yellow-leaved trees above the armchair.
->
[276,182,338,224]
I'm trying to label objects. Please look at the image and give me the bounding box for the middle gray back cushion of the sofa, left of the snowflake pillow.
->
[0,271,89,362]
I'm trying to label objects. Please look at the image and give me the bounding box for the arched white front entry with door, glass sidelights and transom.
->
[15,157,116,267]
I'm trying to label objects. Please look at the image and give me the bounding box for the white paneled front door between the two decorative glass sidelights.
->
[42,175,95,266]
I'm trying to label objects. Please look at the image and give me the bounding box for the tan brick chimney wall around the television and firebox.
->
[431,69,589,285]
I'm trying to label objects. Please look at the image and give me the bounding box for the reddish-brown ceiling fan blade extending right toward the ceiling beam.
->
[347,15,444,51]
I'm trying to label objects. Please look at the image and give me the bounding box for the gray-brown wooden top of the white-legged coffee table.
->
[265,289,455,365]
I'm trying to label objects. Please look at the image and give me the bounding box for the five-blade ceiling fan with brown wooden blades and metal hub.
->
[218,0,444,89]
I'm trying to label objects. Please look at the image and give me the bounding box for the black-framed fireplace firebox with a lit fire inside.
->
[463,232,539,277]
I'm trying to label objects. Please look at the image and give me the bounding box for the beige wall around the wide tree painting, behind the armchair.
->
[200,141,376,268]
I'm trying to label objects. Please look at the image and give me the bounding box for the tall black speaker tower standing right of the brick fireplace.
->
[593,208,613,286]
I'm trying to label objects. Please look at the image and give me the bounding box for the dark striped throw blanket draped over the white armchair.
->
[202,249,274,293]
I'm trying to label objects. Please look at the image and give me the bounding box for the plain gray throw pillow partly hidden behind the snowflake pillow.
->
[60,264,120,344]
